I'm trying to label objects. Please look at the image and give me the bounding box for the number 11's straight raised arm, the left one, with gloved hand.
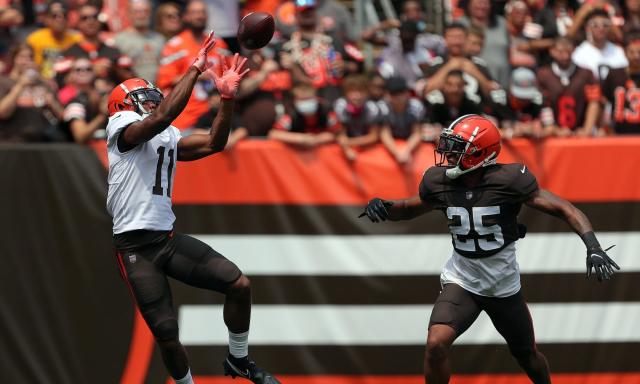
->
[120,31,216,148]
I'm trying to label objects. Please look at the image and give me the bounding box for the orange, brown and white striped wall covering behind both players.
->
[0,137,640,384]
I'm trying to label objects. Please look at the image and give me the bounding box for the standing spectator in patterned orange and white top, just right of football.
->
[276,0,347,103]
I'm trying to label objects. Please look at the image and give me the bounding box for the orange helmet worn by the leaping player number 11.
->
[108,77,164,117]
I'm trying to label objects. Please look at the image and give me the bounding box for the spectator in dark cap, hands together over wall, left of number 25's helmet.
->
[380,77,425,165]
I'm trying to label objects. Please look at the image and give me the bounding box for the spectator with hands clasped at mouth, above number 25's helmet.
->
[416,23,507,112]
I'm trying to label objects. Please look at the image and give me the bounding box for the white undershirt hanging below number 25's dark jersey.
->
[440,241,520,297]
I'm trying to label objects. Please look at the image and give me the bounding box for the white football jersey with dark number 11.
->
[107,111,182,234]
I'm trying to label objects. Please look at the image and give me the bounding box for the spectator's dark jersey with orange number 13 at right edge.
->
[602,68,640,134]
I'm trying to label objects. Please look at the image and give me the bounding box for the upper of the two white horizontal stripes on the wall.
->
[193,232,640,276]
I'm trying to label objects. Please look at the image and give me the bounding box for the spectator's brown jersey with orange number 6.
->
[538,66,601,130]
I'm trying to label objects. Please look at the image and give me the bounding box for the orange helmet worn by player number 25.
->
[434,115,501,179]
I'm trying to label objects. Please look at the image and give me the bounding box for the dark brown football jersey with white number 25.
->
[420,163,538,259]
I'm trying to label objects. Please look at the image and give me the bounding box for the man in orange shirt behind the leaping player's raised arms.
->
[157,0,229,129]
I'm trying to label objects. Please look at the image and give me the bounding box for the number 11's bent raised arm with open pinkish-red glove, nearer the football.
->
[178,53,249,161]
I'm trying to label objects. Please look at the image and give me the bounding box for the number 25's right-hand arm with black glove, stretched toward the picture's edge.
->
[525,189,620,281]
